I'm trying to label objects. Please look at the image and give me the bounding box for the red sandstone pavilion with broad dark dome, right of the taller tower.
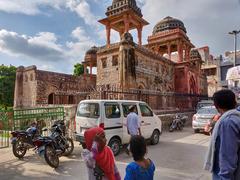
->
[147,16,194,62]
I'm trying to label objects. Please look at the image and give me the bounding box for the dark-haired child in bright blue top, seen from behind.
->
[124,135,155,180]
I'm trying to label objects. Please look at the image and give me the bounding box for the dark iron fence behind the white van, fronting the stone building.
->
[88,86,208,114]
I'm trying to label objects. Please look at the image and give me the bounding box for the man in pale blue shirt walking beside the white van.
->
[126,105,142,155]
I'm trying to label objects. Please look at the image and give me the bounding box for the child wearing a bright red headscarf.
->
[82,127,121,180]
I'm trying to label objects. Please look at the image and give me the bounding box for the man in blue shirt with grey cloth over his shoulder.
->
[204,89,240,180]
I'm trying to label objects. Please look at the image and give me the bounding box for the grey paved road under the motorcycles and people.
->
[0,128,210,180]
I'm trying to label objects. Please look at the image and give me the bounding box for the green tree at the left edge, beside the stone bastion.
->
[0,65,16,107]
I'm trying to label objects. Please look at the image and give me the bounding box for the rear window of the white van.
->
[77,103,99,118]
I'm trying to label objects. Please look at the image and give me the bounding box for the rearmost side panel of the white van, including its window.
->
[104,102,123,140]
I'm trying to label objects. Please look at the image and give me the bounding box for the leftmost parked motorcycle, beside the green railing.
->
[11,123,39,159]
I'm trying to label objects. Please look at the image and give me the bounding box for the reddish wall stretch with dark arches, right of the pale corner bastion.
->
[36,71,96,104]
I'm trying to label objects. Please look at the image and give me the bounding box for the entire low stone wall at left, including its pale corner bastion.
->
[14,66,96,107]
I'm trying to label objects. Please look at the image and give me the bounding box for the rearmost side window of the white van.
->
[105,103,121,119]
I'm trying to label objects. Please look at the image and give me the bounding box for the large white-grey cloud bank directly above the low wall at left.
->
[0,27,98,73]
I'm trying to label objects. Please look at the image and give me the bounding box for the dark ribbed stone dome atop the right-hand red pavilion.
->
[153,16,187,35]
